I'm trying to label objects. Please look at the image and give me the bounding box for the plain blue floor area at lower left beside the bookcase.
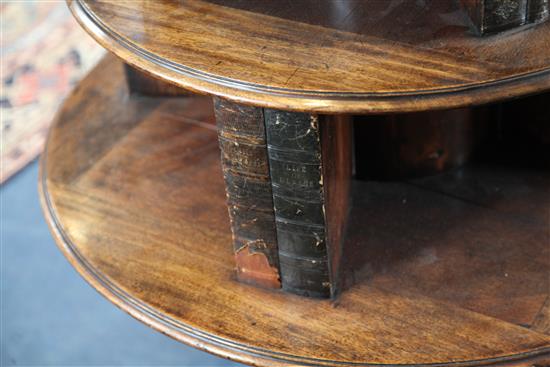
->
[0,162,240,367]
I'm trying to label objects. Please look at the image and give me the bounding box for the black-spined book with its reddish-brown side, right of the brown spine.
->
[264,109,351,297]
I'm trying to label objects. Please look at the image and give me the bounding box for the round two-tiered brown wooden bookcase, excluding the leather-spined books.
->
[39,0,550,367]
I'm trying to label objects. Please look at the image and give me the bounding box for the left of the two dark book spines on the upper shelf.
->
[460,0,528,36]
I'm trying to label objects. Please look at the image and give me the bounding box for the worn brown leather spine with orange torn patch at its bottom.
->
[214,98,281,288]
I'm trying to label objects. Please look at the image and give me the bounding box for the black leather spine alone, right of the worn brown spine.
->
[264,109,331,297]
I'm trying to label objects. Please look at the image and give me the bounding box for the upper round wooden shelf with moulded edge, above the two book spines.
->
[69,0,550,113]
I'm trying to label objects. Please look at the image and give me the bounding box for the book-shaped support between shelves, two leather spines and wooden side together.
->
[215,98,351,297]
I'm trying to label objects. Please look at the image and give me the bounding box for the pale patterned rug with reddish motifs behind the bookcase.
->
[0,0,105,183]
